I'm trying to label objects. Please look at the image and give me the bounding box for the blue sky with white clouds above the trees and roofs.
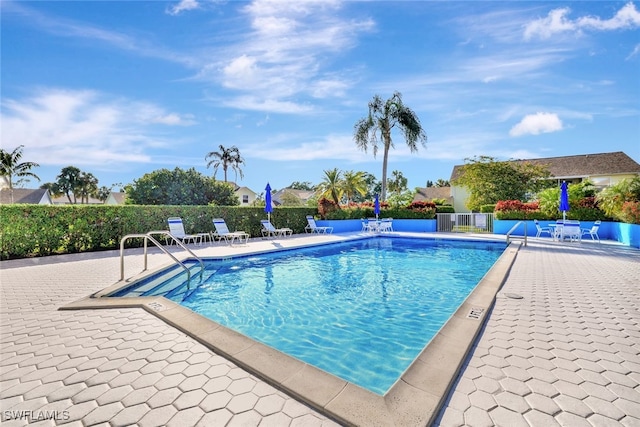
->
[0,0,640,193]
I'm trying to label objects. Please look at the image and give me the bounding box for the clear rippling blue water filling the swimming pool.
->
[115,237,506,394]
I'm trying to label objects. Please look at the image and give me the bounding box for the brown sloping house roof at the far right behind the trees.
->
[451,151,640,181]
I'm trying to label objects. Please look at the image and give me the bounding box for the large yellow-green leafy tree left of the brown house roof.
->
[454,156,549,211]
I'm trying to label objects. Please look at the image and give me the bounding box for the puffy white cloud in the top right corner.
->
[524,2,640,40]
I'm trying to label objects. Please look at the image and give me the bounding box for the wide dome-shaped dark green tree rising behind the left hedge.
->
[127,168,240,206]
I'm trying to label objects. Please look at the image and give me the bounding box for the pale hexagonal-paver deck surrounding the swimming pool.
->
[0,233,640,426]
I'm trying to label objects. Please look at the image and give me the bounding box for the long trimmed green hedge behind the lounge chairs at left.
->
[0,204,318,260]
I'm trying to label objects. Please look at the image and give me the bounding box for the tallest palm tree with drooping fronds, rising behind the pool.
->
[353,92,427,200]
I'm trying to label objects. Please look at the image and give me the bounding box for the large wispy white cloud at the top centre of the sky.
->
[199,0,374,113]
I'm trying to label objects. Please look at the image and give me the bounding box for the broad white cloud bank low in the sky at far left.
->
[0,89,192,166]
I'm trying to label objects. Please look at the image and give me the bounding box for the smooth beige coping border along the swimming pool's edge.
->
[60,239,520,426]
